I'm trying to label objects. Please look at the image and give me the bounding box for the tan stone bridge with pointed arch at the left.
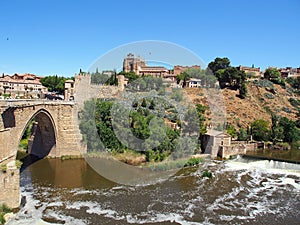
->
[0,99,86,207]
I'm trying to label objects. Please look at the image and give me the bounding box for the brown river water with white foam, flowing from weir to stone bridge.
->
[9,158,300,225]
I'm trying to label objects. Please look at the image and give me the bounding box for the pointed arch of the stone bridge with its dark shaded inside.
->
[18,108,57,158]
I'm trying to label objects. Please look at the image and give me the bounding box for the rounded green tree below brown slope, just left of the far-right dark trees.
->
[251,119,270,141]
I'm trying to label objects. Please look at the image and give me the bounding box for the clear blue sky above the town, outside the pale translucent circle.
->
[0,0,300,76]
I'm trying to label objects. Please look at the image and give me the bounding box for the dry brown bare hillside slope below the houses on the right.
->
[185,81,300,129]
